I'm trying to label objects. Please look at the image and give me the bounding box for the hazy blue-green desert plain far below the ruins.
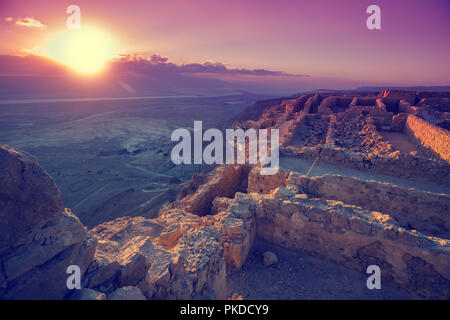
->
[0,95,261,227]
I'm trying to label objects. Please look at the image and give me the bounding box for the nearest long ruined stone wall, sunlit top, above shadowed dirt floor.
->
[251,188,450,299]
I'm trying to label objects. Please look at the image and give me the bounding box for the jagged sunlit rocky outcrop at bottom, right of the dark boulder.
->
[86,212,226,299]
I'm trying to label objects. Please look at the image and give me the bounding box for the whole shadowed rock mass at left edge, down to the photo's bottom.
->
[0,145,96,299]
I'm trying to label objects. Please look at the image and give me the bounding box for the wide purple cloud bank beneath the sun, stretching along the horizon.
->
[0,54,362,99]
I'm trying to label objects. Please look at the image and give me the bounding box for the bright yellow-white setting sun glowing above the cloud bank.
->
[46,27,115,74]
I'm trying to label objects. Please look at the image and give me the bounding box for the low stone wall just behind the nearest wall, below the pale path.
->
[248,169,450,237]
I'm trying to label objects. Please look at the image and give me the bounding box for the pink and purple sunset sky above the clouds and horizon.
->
[0,0,450,97]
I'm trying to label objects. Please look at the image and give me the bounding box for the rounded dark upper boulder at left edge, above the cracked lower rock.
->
[0,145,64,251]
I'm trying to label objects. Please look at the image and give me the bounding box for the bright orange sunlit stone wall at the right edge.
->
[404,115,450,162]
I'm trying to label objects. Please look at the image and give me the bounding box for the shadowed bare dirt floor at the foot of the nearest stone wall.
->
[227,240,411,300]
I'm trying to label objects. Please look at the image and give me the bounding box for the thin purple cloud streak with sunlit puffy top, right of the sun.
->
[113,54,309,77]
